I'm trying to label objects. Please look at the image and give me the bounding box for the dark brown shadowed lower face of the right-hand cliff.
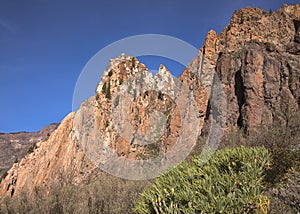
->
[217,41,300,130]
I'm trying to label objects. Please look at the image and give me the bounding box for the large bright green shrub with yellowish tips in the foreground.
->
[134,147,270,213]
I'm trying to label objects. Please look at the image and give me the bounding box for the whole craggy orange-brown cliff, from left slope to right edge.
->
[0,5,300,197]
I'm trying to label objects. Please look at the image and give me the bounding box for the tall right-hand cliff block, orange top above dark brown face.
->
[216,5,300,130]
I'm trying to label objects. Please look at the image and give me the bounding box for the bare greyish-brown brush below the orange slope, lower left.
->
[0,175,149,214]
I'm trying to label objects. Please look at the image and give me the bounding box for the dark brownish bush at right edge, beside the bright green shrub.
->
[247,110,300,187]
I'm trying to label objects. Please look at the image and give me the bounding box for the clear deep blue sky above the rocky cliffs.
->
[0,0,299,132]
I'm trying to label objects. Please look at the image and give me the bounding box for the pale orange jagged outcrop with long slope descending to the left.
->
[0,54,204,196]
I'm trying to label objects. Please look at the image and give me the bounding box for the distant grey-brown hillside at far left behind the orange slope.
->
[0,124,58,170]
